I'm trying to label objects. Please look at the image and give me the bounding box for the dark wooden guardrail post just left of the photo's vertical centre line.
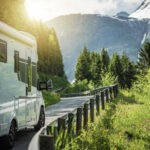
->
[68,113,74,134]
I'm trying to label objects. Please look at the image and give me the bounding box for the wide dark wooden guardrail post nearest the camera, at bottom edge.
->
[39,134,55,150]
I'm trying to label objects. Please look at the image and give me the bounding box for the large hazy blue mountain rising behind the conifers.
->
[46,0,150,81]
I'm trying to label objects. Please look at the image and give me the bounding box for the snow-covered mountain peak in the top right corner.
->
[130,0,150,19]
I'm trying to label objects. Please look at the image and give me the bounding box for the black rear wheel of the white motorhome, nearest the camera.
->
[5,121,17,148]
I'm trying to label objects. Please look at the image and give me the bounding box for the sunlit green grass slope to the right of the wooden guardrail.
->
[67,91,150,150]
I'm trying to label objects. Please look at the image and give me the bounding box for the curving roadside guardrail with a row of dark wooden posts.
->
[39,85,118,150]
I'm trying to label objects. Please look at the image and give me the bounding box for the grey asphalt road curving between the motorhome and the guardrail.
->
[0,96,92,150]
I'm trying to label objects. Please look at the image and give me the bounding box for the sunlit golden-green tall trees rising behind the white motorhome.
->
[0,0,64,76]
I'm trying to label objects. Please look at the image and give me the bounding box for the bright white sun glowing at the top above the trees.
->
[25,0,42,20]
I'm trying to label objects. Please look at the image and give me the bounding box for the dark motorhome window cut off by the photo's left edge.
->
[0,39,7,63]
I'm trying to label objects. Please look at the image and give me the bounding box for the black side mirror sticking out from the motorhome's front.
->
[38,79,53,91]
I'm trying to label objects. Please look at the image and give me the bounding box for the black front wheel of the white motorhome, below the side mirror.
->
[34,107,45,131]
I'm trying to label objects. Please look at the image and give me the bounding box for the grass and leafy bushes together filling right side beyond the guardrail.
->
[56,43,150,150]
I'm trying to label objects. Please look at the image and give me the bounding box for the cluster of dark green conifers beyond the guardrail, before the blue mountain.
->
[75,47,137,88]
